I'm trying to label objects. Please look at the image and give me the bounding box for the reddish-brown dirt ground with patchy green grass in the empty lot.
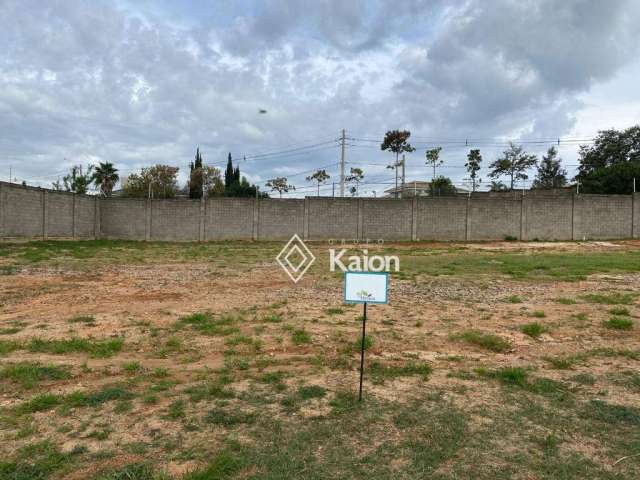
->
[0,241,640,479]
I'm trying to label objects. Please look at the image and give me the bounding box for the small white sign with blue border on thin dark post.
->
[344,272,389,402]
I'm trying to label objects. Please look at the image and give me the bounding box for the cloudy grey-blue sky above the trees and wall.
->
[0,0,640,196]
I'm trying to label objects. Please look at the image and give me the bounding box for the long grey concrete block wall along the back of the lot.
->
[0,182,640,241]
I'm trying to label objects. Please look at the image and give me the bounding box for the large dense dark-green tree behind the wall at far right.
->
[576,125,640,194]
